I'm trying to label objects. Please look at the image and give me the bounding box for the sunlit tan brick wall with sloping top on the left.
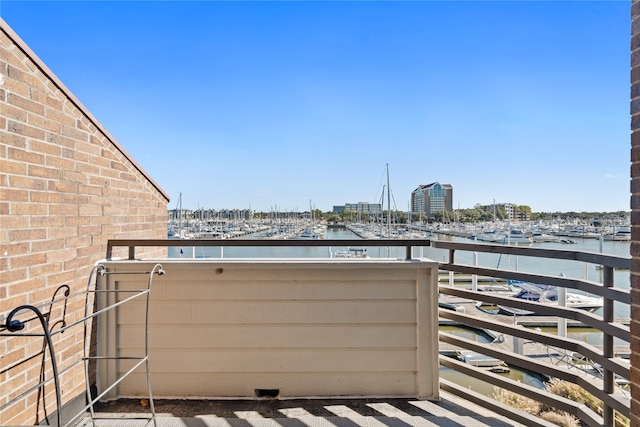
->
[0,19,168,425]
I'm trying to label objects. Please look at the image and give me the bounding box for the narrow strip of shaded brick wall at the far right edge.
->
[631,0,640,427]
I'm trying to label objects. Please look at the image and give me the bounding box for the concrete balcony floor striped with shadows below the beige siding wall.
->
[80,391,523,427]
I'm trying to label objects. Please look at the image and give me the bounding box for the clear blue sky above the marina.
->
[0,0,630,212]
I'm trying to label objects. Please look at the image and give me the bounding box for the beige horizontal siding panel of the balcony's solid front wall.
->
[101,261,437,397]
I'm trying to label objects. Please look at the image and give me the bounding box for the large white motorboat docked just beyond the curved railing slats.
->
[498,283,603,316]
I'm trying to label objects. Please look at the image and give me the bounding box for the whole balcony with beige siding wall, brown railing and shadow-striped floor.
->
[0,240,630,426]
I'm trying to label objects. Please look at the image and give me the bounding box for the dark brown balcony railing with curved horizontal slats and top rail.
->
[105,239,630,426]
